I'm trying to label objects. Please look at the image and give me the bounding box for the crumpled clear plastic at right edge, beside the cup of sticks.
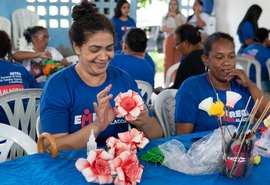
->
[254,128,270,157]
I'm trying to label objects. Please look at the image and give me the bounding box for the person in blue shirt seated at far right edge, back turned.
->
[242,28,270,91]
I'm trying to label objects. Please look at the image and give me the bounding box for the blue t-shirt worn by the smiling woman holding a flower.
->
[40,65,143,145]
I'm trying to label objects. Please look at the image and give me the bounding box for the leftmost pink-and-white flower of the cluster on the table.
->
[75,149,115,184]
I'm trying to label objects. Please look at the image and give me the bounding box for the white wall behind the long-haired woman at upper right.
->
[214,0,270,51]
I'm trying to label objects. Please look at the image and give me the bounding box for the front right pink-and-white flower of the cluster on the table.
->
[113,151,143,185]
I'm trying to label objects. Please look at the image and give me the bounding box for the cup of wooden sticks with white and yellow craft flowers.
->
[199,91,270,178]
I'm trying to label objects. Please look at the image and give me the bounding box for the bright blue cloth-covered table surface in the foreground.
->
[0,132,270,185]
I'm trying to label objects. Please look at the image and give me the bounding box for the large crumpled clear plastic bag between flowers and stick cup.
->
[158,125,236,175]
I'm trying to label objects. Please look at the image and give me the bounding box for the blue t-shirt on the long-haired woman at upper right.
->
[237,21,255,45]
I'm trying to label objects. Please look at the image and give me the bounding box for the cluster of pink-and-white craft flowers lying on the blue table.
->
[75,128,149,185]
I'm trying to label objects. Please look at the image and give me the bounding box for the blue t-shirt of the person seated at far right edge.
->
[242,43,270,83]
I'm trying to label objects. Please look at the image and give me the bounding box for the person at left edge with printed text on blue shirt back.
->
[0,30,39,124]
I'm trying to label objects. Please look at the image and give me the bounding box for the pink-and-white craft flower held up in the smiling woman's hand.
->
[114,90,144,120]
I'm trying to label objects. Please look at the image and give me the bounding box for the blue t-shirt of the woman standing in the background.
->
[112,17,136,51]
